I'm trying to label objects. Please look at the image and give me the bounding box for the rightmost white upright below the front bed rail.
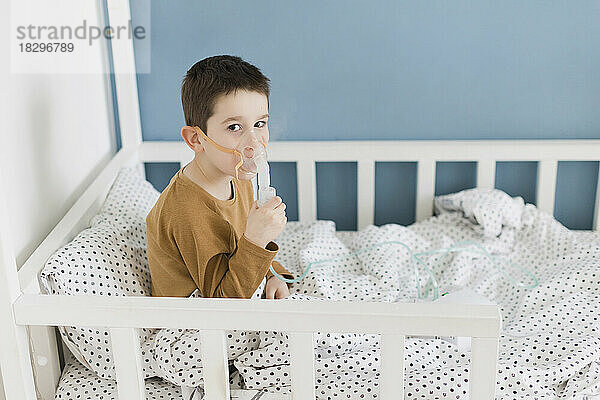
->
[469,337,498,400]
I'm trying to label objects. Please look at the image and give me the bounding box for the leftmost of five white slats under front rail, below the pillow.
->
[110,328,146,400]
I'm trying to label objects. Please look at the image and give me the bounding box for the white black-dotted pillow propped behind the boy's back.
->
[40,164,160,379]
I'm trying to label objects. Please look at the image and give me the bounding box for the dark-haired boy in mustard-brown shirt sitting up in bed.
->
[146,55,293,299]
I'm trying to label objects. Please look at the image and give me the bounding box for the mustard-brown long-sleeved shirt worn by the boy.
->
[146,168,293,299]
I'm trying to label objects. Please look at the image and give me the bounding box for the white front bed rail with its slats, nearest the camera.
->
[14,294,501,400]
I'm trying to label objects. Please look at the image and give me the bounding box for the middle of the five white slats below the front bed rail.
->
[289,333,316,400]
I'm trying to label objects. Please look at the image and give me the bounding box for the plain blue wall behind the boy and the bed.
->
[132,0,600,229]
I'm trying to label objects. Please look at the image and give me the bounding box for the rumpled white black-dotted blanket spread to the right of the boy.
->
[153,191,600,399]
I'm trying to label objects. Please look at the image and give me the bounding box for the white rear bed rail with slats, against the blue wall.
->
[140,140,600,230]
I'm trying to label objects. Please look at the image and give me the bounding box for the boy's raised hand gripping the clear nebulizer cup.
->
[244,196,287,247]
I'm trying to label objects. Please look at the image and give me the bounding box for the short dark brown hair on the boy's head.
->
[181,55,270,134]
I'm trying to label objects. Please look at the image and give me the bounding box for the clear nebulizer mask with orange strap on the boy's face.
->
[193,126,276,206]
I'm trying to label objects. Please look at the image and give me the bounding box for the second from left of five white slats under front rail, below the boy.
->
[201,330,230,400]
